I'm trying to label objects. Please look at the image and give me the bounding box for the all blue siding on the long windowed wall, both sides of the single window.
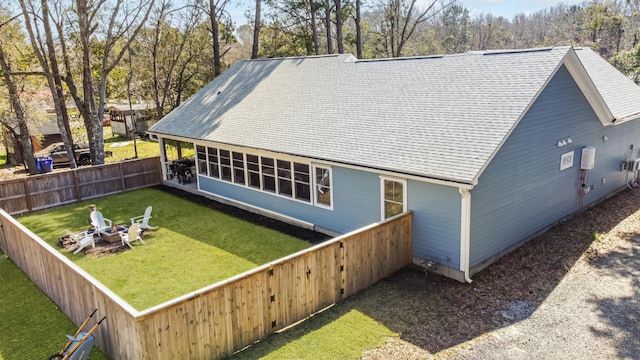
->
[198,162,460,268]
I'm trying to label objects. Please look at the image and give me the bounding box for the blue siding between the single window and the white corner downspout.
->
[407,180,461,269]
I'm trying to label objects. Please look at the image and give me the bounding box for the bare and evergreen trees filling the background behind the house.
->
[0,0,640,173]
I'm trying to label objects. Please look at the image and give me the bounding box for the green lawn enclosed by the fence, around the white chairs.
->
[18,189,311,310]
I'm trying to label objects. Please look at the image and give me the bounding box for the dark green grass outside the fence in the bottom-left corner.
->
[0,252,107,360]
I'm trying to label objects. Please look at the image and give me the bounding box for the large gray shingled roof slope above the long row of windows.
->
[149,47,640,184]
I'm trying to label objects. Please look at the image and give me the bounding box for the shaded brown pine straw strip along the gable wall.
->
[358,189,640,359]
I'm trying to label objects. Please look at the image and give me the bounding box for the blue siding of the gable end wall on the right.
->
[470,66,640,266]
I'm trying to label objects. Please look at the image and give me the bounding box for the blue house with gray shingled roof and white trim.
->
[149,47,640,281]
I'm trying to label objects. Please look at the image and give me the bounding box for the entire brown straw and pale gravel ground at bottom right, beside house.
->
[360,189,640,359]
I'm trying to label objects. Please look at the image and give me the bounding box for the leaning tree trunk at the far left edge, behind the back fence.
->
[0,44,38,175]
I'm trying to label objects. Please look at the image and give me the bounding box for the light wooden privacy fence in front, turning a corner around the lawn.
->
[0,210,412,360]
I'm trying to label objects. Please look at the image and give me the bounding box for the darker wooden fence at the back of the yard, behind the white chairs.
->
[0,157,162,215]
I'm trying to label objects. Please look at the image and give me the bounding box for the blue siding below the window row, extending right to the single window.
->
[198,166,380,233]
